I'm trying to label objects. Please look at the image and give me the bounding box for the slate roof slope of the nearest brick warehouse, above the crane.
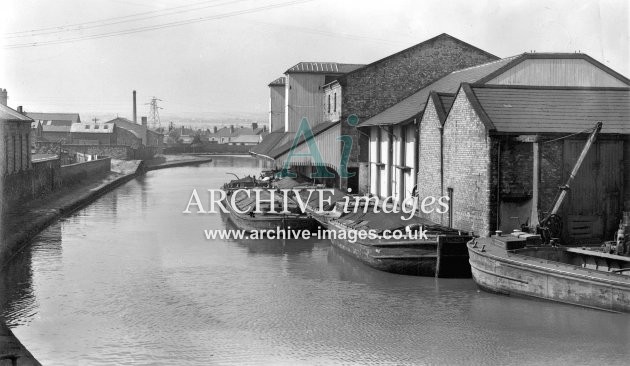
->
[462,84,630,134]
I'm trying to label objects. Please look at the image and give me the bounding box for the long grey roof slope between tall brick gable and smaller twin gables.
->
[360,55,522,126]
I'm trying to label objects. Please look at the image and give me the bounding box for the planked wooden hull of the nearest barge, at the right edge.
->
[467,239,630,312]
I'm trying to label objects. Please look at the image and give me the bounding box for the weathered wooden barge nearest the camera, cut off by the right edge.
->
[467,233,630,312]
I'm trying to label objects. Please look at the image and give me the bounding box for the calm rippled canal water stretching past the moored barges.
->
[0,157,630,365]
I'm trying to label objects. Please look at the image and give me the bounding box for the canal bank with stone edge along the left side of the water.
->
[0,156,212,365]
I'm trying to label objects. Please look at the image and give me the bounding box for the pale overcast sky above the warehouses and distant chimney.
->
[0,0,630,118]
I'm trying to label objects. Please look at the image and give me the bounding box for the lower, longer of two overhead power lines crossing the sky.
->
[3,0,315,49]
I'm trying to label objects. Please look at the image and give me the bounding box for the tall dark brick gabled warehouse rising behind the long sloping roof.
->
[271,34,504,192]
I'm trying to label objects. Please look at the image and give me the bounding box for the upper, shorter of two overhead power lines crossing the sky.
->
[5,0,249,38]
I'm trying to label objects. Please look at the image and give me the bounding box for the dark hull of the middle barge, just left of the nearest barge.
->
[328,221,471,278]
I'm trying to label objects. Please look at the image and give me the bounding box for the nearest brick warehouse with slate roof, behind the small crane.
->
[419,83,630,240]
